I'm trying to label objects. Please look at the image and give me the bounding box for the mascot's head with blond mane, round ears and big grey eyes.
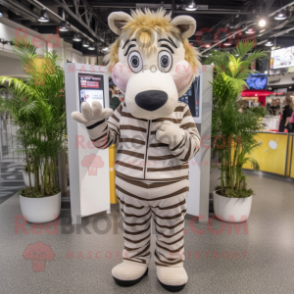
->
[105,9,200,119]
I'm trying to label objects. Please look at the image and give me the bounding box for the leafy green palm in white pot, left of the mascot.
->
[0,39,66,223]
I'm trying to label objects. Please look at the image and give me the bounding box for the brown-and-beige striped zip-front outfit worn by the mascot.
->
[87,102,200,266]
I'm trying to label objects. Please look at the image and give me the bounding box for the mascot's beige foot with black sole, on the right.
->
[156,266,188,292]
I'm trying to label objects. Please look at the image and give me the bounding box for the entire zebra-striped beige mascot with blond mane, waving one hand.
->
[72,10,200,291]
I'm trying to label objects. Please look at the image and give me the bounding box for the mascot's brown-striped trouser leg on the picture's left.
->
[115,177,152,265]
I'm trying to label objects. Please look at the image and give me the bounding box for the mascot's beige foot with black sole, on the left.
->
[112,260,148,287]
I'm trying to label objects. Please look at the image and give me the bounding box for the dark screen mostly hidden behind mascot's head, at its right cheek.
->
[179,77,200,117]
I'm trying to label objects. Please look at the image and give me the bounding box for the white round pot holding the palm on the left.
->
[19,192,61,223]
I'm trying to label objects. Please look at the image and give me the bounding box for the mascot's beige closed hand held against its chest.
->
[156,121,185,146]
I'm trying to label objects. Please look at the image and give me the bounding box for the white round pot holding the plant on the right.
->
[213,191,252,223]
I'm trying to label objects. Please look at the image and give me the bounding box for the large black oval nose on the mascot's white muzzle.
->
[135,90,168,111]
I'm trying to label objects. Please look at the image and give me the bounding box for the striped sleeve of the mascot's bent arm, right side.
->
[170,105,200,162]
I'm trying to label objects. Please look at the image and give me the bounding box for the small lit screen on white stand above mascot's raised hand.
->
[78,74,105,108]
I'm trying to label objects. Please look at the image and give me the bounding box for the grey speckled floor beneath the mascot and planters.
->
[0,171,294,294]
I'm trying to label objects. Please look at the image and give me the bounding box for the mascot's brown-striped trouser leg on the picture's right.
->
[149,179,189,267]
